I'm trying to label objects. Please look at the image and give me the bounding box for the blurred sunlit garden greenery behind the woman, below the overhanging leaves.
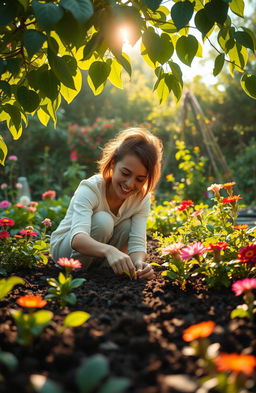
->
[0,6,256,205]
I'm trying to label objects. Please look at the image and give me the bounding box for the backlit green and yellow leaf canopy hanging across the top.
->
[0,0,256,164]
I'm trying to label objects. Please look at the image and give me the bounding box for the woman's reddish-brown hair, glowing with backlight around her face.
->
[98,128,163,197]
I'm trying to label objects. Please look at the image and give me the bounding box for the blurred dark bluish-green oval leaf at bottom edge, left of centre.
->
[75,355,109,393]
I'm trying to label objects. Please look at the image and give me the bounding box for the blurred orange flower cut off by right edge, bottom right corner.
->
[214,353,256,375]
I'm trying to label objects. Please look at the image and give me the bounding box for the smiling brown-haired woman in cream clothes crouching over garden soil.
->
[51,128,162,279]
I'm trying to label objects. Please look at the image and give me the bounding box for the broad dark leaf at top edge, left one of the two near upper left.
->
[32,0,64,30]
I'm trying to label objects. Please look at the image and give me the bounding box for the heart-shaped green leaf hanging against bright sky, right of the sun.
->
[176,34,198,66]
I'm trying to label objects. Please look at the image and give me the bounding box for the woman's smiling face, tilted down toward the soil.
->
[110,154,148,201]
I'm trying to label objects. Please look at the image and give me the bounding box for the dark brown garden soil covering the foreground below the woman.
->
[0,242,256,393]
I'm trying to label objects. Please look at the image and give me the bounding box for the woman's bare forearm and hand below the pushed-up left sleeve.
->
[71,233,135,276]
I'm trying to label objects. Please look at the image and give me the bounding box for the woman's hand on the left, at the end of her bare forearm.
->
[106,246,135,277]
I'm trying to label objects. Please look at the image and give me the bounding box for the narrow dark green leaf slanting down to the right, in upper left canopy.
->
[48,48,75,89]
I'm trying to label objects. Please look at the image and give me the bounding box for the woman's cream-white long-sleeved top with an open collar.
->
[50,174,150,254]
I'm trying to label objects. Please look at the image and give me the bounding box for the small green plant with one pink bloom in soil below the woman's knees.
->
[45,258,86,308]
